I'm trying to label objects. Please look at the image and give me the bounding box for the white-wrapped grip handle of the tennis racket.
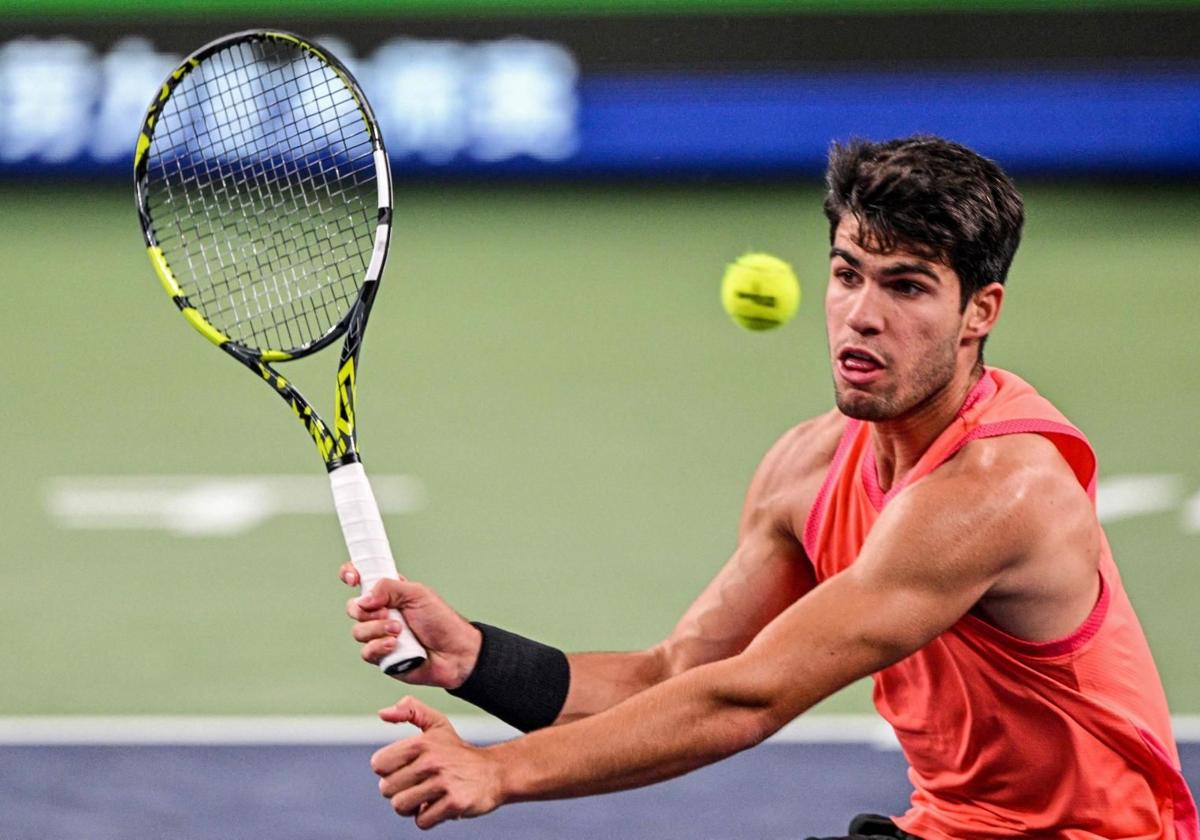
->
[329,463,426,677]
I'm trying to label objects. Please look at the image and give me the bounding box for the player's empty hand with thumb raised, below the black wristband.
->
[371,697,504,829]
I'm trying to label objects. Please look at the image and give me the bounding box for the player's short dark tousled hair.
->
[824,134,1025,310]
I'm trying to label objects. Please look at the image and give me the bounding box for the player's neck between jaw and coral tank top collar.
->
[871,365,983,492]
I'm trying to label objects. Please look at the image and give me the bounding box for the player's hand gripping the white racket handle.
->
[341,564,482,689]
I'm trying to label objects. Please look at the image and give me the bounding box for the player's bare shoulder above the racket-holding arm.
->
[743,410,846,533]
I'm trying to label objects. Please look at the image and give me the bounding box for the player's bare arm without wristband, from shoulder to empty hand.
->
[372,436,1098,828]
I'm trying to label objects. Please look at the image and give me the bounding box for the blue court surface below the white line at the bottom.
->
[0,724,1200,840]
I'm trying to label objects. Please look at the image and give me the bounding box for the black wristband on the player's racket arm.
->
[449,622,571,732]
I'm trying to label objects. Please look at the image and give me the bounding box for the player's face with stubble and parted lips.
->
[826,215,974,421]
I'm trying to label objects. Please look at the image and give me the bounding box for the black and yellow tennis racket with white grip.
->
[133,30,426,676]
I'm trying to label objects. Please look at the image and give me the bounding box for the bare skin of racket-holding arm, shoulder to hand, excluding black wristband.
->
[341,413,842,725]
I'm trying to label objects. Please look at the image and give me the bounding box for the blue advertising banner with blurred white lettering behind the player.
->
[0,37,1200,176]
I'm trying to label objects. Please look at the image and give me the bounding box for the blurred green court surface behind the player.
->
[0,184,1200,715]
